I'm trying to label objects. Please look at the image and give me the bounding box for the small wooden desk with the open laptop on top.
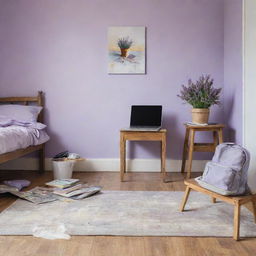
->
[120,129,167,181]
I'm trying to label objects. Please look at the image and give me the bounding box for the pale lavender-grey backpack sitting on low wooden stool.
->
[196,143,250,195]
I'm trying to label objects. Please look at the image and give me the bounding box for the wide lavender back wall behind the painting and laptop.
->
[0,0,224,159]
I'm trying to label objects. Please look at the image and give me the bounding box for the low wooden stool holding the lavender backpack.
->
[180,179,256,240]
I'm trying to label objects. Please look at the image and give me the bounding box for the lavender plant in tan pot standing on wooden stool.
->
[178,75,221,124]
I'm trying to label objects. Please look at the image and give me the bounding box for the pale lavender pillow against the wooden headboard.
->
[0,104,43,122]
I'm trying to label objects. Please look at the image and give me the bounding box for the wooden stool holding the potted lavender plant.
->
[181,124,225,179]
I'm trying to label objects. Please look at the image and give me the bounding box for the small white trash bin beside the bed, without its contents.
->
[52,159,75,180]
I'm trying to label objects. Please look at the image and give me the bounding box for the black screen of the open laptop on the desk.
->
[130,105,162,126]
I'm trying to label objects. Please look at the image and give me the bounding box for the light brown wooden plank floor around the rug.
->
[0,171,256,256]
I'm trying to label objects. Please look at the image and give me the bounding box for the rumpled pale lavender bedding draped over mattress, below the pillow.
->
[0,125,49,154]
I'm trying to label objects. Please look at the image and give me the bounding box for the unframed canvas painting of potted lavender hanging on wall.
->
[108,27,145,74]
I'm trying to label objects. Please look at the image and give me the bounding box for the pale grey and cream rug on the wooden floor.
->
[0,191,256,237]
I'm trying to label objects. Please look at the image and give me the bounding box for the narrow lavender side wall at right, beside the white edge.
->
[224,0,243,144]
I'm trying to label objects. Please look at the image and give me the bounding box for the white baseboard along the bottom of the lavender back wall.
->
[0,158,208,172]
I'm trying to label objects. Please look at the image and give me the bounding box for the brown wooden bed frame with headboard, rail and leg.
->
[0,91,45,173]
